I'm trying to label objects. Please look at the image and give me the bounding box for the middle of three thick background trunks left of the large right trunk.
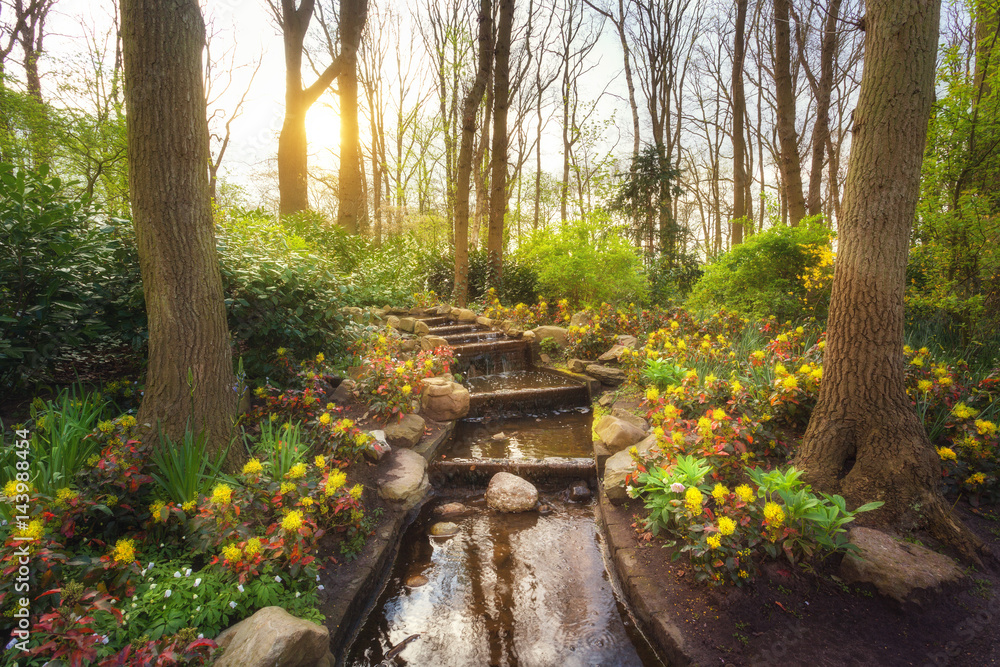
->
[774,0,806,227]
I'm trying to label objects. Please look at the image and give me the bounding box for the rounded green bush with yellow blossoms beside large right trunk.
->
[688,218,833,321]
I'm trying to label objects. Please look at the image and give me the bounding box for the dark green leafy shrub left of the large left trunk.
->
[0,164,144,386]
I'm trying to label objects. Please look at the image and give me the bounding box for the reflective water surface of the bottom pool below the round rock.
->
[346,501,660,667]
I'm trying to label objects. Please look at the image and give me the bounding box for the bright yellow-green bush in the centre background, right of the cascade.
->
[518,214,649,307]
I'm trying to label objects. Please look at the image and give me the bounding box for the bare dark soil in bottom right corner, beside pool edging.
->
[600,501,1000,667]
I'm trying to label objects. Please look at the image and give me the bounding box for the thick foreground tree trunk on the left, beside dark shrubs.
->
[122,0,240,466]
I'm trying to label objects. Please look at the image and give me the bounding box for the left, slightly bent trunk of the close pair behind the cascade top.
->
[455,0,493,307]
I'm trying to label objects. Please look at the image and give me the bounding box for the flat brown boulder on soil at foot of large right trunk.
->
[840,526,964,602]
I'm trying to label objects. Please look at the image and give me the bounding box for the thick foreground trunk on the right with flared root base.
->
[796,0,981,560]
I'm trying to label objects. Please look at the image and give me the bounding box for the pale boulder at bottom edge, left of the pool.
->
[215,607,334,667]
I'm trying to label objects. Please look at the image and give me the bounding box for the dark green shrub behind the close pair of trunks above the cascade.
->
[425,248,538,304]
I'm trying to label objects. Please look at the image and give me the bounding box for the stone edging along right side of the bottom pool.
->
[596,479,701,667]
